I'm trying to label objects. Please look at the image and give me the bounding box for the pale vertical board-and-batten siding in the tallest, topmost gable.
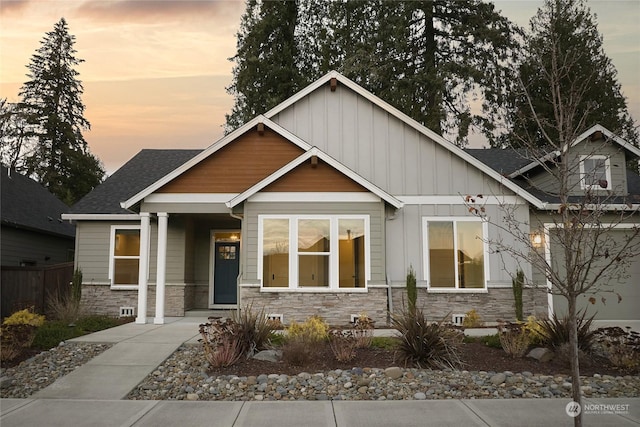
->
[272,85,495,195]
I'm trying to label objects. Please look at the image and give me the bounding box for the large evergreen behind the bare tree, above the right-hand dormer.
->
[492,0,638,149]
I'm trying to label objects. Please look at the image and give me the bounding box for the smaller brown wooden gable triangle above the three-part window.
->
[262,157,369,192]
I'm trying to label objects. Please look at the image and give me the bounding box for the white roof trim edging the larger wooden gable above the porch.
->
[120,116,311,209]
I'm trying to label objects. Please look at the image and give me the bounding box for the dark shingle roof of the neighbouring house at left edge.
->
[0,166,76,237]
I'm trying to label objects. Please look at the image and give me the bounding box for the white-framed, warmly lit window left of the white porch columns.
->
[110,226,140,286]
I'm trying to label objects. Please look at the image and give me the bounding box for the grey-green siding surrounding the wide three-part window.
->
[242,202,386,284]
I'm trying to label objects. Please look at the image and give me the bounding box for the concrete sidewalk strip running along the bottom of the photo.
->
[0,399,640,427]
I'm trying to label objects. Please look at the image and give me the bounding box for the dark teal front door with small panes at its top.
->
[213,242,240,305]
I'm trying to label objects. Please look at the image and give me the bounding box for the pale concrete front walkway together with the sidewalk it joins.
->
[0,317,640,427]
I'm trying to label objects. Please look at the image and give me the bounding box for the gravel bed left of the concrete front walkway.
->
[0,342,112,398]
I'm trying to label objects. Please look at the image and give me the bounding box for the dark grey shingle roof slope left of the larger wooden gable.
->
[69,149,202,214]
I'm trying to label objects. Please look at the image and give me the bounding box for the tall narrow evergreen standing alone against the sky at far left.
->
[19,18,104,204]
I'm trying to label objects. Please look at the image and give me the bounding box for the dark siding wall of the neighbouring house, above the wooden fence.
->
[0,226,75,266]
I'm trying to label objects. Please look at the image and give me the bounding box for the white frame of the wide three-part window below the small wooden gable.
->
[258,215,371,292]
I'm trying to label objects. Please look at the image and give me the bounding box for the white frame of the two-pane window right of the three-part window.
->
[422,216,490,293]
